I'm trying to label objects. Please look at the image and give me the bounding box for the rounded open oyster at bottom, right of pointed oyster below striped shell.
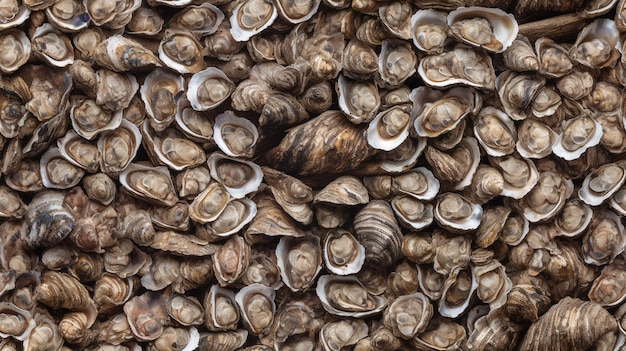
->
[383,292,433,340]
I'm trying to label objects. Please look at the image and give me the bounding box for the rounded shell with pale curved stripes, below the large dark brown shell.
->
[354,200,403,267]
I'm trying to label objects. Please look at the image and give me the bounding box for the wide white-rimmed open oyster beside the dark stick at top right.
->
[447,7,518,52]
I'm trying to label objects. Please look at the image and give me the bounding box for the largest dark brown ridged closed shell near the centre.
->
[261,111,375,175]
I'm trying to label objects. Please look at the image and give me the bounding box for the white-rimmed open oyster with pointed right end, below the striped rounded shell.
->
[316,275,387,318]
